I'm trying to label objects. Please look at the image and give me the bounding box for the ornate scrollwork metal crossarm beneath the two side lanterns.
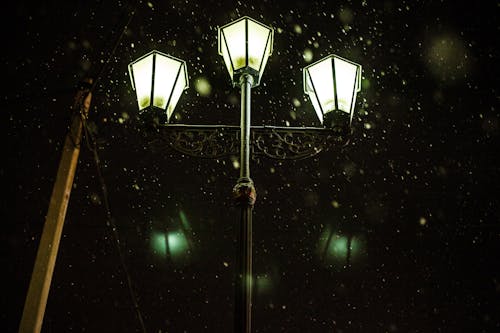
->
[158,124,348,160]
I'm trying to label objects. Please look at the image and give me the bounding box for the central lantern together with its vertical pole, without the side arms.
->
[218,16,273,332]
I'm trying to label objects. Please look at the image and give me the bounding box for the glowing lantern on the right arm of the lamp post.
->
[304,55,361,123]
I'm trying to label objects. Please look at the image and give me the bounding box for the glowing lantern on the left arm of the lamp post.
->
[129,51,188,120]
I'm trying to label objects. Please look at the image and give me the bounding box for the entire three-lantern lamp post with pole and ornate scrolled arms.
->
[129,16,361,333]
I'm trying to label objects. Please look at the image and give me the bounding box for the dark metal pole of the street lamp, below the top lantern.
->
[233,74,257,333]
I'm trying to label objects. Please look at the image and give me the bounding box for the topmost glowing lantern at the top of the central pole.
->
[218,16,273,86]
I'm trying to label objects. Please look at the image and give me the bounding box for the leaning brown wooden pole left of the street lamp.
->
[19,79,92,333]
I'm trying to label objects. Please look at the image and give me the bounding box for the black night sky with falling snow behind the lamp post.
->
[0,0,500,333]
